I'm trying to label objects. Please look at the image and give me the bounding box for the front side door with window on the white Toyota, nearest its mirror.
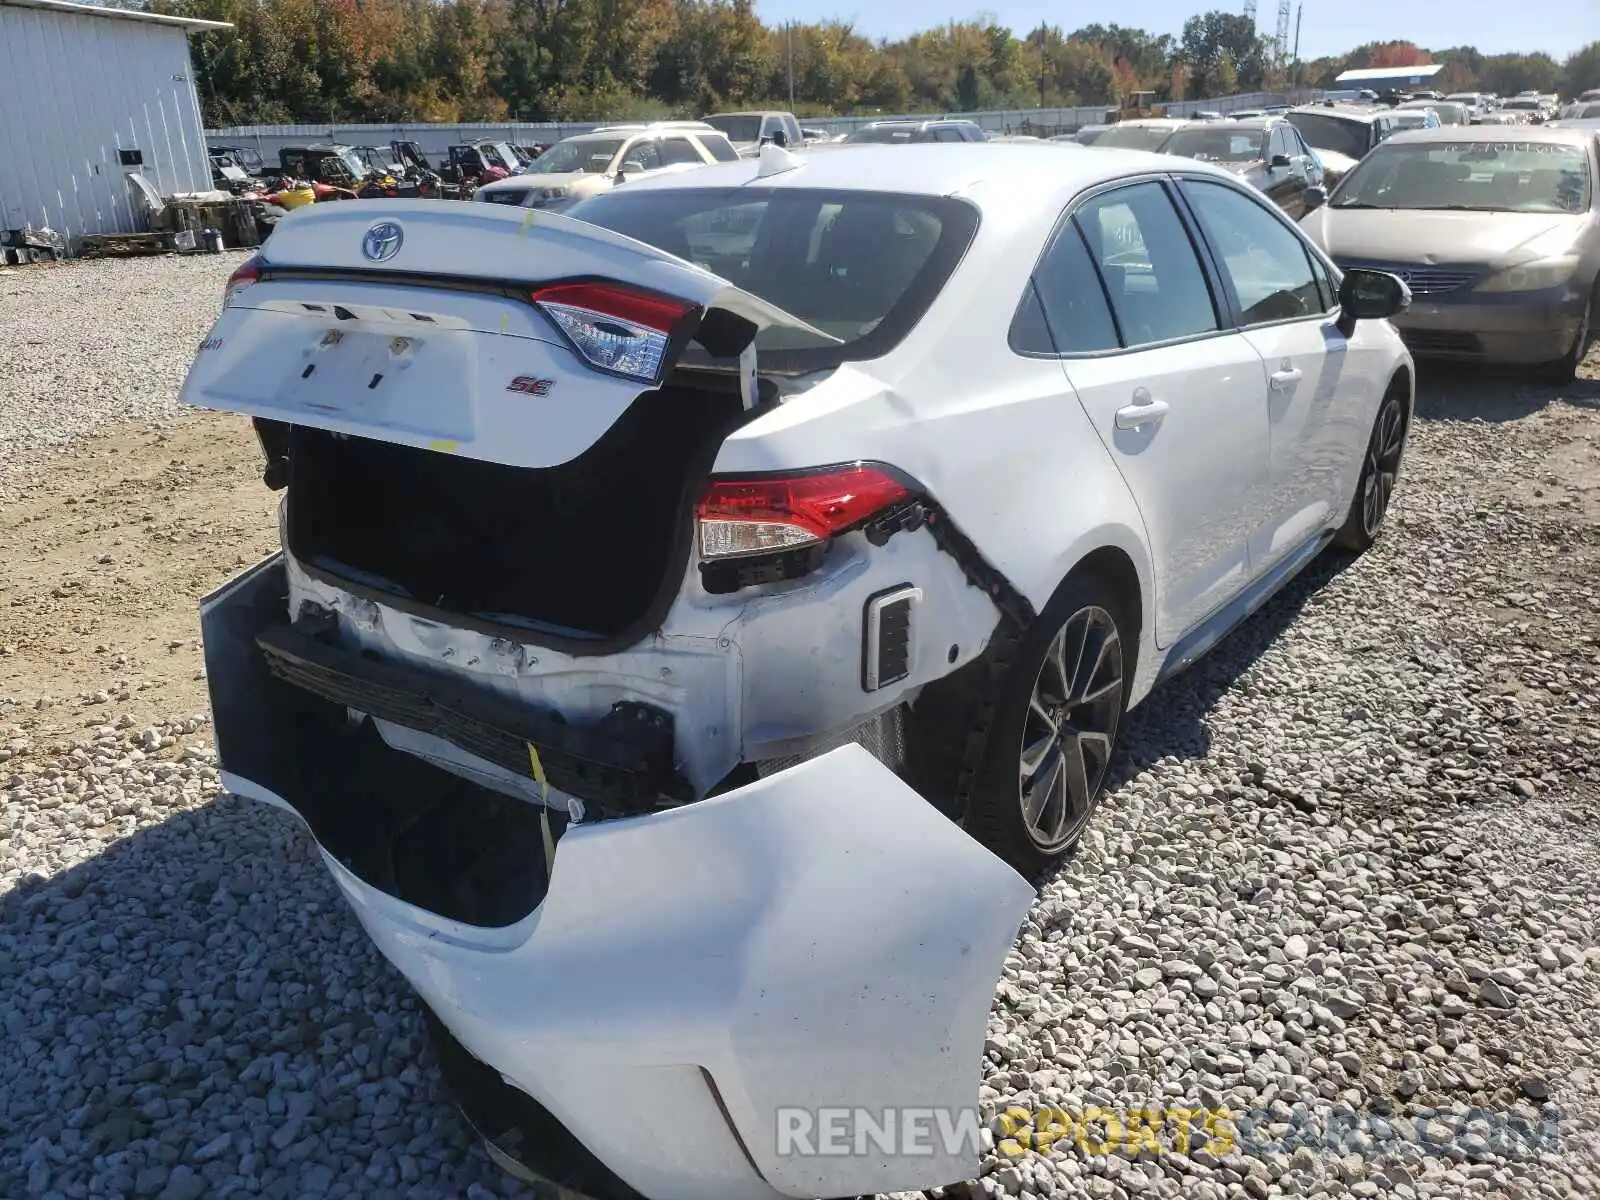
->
[1181,178,1370,573]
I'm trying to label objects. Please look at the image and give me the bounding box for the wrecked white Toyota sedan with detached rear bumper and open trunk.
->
[184,144,1413,1200]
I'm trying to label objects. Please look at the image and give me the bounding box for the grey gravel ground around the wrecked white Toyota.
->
[0,259,1600,1200]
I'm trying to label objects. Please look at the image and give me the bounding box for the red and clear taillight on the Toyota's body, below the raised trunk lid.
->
[694,462,914,558]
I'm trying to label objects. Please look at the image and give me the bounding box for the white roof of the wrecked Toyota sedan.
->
[595,141,1234,208]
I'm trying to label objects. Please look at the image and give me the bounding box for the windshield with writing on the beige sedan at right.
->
[1331,141,1592,213]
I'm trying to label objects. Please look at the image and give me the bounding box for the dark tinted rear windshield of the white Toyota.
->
[566,187,978,373]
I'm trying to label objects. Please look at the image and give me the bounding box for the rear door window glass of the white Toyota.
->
[1077,182,1219,346]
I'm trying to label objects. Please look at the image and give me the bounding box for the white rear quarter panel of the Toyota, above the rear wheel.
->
[715,194,1154,700]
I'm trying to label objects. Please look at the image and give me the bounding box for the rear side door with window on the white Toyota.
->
[1061,179,1269,646]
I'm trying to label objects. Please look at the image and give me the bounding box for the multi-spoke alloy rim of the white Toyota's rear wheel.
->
[1018,605,1122,851]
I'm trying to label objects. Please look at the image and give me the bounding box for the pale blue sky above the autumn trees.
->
[757,0,1600,59]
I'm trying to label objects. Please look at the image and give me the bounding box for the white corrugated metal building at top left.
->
[0,0,230,246]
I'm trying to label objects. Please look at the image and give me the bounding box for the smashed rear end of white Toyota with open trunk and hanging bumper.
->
[184,202,1032,1200]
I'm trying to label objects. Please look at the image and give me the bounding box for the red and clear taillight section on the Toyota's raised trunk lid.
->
[533,283,694,384]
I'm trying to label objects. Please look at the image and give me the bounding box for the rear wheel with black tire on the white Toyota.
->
[965,571,1138,878]
